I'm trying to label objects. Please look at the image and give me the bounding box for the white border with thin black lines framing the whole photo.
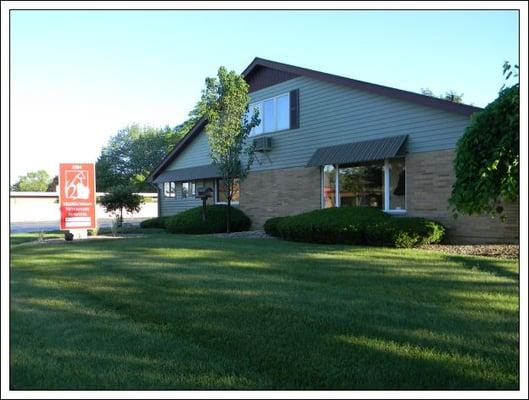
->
[0,1,529,399]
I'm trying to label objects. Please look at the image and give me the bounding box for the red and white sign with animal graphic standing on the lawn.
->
[59,164,96,230]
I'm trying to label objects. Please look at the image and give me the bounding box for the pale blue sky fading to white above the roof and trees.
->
[10,10,518,182]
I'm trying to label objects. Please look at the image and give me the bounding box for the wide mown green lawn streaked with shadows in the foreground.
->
[10,234,519,389]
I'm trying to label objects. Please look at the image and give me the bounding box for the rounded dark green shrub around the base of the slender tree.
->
[166,204,251,234]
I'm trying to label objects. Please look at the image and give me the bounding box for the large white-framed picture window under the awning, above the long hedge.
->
[322,159,406,212]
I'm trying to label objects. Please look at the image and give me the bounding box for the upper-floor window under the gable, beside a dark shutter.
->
[248,93,290,136]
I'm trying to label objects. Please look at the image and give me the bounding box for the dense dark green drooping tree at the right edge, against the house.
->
[449,63,520,217]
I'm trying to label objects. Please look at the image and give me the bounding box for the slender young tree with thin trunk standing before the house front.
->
[199,67,260,232]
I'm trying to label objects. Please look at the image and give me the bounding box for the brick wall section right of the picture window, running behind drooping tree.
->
[406,150,519,243]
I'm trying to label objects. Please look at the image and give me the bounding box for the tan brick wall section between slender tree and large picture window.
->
[239,167,321,229]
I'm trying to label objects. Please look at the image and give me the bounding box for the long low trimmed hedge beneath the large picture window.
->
[264,207,445,247]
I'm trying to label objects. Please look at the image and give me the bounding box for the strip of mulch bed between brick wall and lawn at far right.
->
[420,244,520,260]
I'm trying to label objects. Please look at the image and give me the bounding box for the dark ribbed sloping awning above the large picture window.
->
[307,135,408,167]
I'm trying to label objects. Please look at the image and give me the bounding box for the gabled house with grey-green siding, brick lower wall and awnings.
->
[149,58,519,242]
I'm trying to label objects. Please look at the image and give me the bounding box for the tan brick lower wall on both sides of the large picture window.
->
[239,150,519,243]
